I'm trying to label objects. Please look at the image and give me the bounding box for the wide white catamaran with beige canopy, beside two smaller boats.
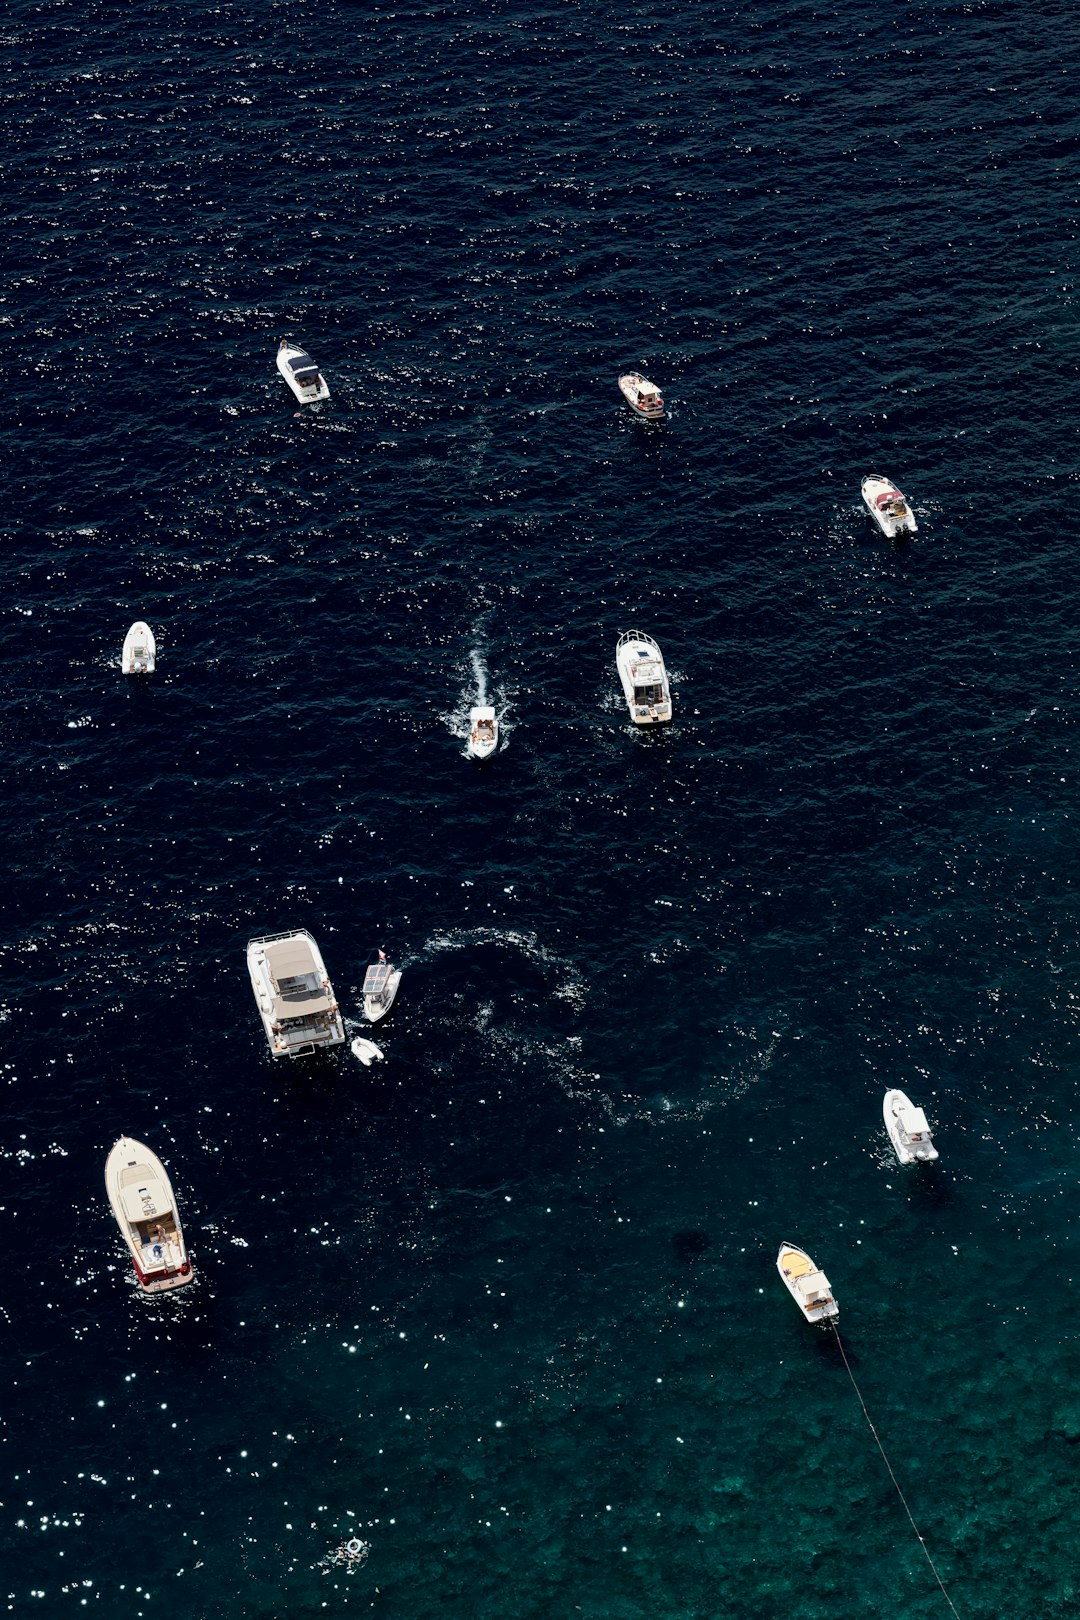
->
[248,928,345,1058]
